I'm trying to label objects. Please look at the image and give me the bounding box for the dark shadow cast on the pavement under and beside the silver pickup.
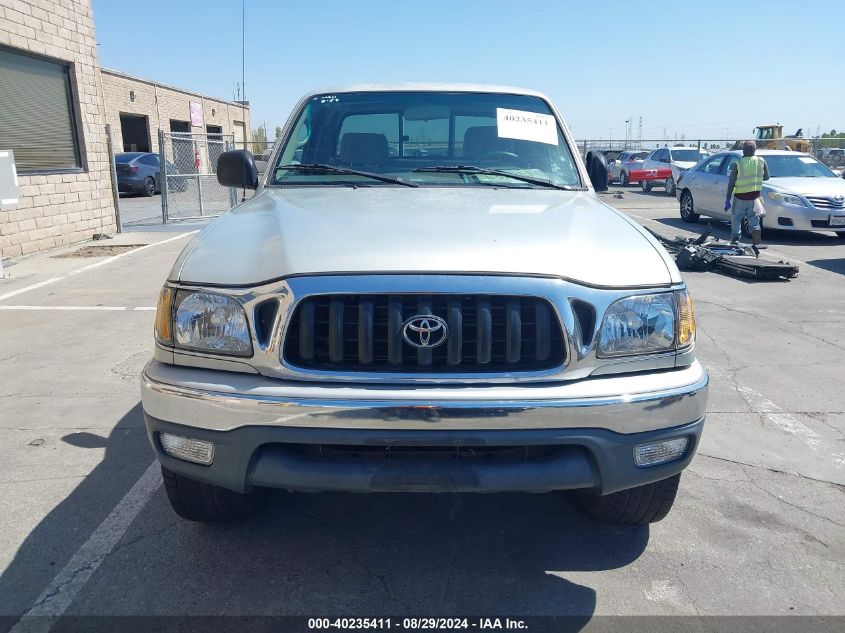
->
[0,405,649,630]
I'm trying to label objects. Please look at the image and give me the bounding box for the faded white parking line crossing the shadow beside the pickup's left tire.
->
[10,461,162,633]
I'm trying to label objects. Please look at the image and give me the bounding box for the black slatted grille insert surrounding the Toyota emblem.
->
[283,294,566,374]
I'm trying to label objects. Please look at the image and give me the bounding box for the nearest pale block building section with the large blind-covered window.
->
[0,0,116,257]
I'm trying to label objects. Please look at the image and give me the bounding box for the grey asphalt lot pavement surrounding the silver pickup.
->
[0,188,845,631]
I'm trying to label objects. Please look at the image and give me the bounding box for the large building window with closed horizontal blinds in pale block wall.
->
[0,48,82,173]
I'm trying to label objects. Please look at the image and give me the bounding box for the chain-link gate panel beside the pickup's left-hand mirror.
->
[159,132,237,223]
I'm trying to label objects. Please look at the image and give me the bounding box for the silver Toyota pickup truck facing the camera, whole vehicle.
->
[141,85,708,524]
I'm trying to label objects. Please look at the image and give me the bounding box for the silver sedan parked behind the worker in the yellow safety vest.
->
[676,150,845,237]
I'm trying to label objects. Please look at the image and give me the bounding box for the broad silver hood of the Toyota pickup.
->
[170,187,680,287]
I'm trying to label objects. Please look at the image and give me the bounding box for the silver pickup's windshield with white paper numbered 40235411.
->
[269,92,582,188]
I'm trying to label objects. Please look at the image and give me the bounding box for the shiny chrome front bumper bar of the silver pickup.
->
[141,361,708,433]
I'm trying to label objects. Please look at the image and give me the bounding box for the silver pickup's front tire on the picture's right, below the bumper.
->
[580,473,681,525]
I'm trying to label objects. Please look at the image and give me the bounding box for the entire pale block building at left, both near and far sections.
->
[0,0,250,257]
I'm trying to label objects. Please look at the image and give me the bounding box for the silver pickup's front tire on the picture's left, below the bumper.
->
[161,466,267,523]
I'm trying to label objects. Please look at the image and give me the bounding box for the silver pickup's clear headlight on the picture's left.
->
[173,290,252,356]
